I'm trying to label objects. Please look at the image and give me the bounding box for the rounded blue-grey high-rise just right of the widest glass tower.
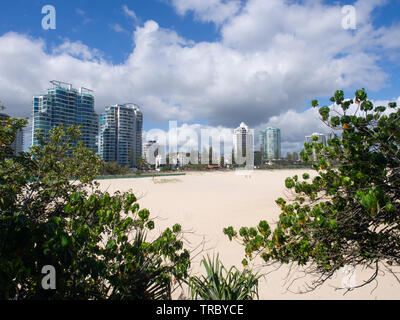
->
[99,104,143,168]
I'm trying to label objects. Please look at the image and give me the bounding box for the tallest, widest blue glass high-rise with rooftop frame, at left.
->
[32,81,99,152]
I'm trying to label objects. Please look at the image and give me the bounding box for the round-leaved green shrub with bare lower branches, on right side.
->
[224,89,400,288]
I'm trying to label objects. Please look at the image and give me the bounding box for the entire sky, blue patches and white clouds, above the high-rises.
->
[0,0,400,152]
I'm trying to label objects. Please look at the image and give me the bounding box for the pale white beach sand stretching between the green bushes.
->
[100,170,400,299]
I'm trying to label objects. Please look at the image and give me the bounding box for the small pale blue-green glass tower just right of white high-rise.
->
[259,128,281,161]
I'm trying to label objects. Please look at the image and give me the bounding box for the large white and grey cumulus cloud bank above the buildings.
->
[0,0,400,152]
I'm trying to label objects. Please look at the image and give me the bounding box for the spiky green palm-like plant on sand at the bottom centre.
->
[188,255,260,300]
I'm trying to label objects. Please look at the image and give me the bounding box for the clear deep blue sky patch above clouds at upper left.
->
[0,0,218,64]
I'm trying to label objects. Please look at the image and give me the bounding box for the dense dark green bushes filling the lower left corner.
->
[0,119,190,299]
